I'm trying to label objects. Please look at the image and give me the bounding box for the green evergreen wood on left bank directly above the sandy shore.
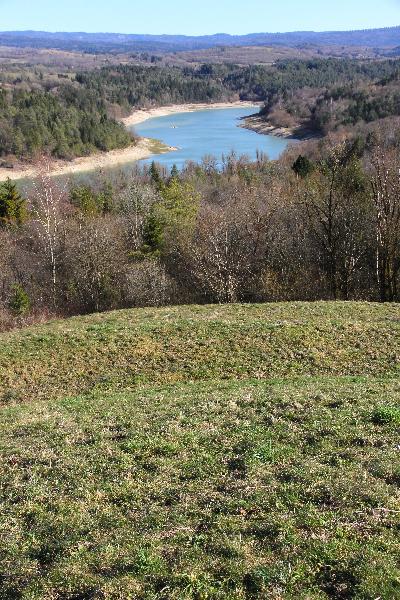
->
[0,85,132,159]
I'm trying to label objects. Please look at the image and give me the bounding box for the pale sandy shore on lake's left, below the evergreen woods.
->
[0,138,176,182]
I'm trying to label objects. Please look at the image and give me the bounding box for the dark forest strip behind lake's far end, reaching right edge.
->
[77,58,399,107]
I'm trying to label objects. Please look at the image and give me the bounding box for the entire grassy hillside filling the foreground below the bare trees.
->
[0,303,400,600]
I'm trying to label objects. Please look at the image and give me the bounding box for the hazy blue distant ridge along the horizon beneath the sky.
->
[0,26,400,52]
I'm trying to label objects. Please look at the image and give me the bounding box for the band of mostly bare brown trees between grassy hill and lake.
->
[0,123,400,327]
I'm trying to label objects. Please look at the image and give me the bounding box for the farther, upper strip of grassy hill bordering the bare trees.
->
[0,303,400,400]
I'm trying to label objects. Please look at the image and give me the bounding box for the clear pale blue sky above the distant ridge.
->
[0,0,400,35]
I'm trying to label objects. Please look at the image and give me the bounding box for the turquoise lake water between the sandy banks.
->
[132,107,288,169]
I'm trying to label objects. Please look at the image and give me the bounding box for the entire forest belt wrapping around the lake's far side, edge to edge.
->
[0,59,400,158]
